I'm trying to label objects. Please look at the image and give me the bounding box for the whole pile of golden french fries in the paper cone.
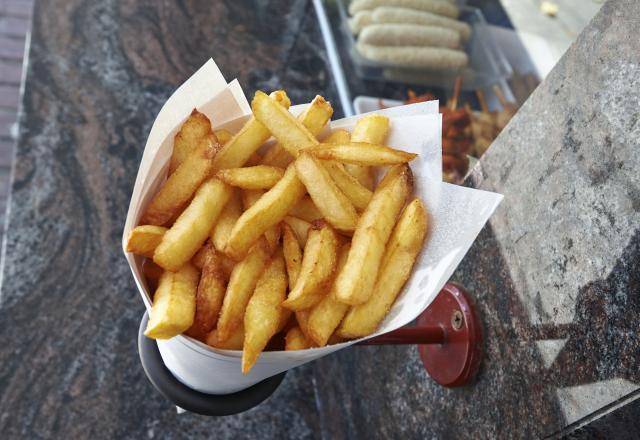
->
[135,91,436,374]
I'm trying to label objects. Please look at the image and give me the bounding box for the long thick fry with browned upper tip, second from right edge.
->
[335,165,413,305]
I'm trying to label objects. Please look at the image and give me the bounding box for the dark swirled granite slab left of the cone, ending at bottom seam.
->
[0,0,337,439]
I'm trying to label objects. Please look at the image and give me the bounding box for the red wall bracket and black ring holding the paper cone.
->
[138,283,482,416]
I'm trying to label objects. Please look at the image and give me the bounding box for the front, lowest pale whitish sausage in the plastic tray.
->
[357,43,469,70]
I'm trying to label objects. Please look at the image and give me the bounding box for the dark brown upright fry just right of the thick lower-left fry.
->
[186,243,227,341]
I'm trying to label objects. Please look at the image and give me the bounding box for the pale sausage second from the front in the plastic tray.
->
[358,24,460,49]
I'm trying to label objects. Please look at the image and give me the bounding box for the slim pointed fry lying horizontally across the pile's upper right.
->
[306,142,418,166]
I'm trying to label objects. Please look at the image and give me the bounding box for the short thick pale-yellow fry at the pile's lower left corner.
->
[144,264,199,339]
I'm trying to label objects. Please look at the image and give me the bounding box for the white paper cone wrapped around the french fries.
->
[122,60,502,394]
